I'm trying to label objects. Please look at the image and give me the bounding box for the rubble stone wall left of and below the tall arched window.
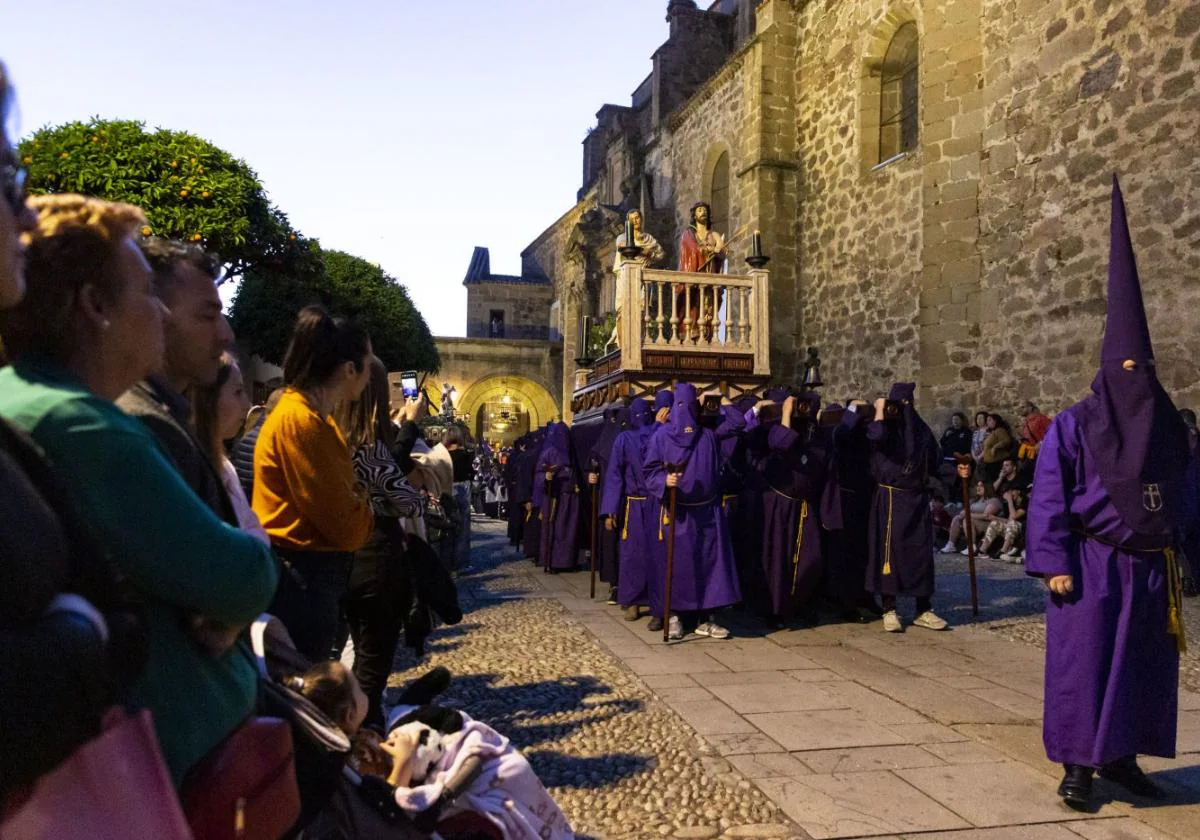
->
[794,0,924,400]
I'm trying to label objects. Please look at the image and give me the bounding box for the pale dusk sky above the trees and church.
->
[0,0,667,335]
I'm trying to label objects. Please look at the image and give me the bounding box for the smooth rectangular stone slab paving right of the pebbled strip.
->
[552,554,1200,840]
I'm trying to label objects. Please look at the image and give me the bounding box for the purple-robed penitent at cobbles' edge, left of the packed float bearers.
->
[534,422,582,570]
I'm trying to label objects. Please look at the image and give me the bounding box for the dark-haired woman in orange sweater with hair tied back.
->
[252,306,374,660]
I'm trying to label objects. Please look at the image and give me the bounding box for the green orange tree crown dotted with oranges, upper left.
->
[19,118,308,275]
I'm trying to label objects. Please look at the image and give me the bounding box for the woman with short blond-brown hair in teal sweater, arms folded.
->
[0,194,277,785]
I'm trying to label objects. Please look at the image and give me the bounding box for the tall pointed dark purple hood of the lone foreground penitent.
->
[1079,175,1188,536]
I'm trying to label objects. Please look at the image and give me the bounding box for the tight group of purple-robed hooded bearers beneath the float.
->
[505,383,947,640]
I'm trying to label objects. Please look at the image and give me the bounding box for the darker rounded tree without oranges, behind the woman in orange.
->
[230,244,440,372]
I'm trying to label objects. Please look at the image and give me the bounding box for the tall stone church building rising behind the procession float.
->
[475,0,1200,420]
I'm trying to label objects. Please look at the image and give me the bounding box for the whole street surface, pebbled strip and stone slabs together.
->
[395,517,1200,840]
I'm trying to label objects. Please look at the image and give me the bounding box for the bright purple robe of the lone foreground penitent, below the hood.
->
[1025,406,1180,767]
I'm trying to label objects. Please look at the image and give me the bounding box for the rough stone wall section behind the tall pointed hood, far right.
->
[979,0,1200,406]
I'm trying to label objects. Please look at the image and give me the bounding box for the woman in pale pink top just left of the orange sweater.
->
[191,353,271,545]
